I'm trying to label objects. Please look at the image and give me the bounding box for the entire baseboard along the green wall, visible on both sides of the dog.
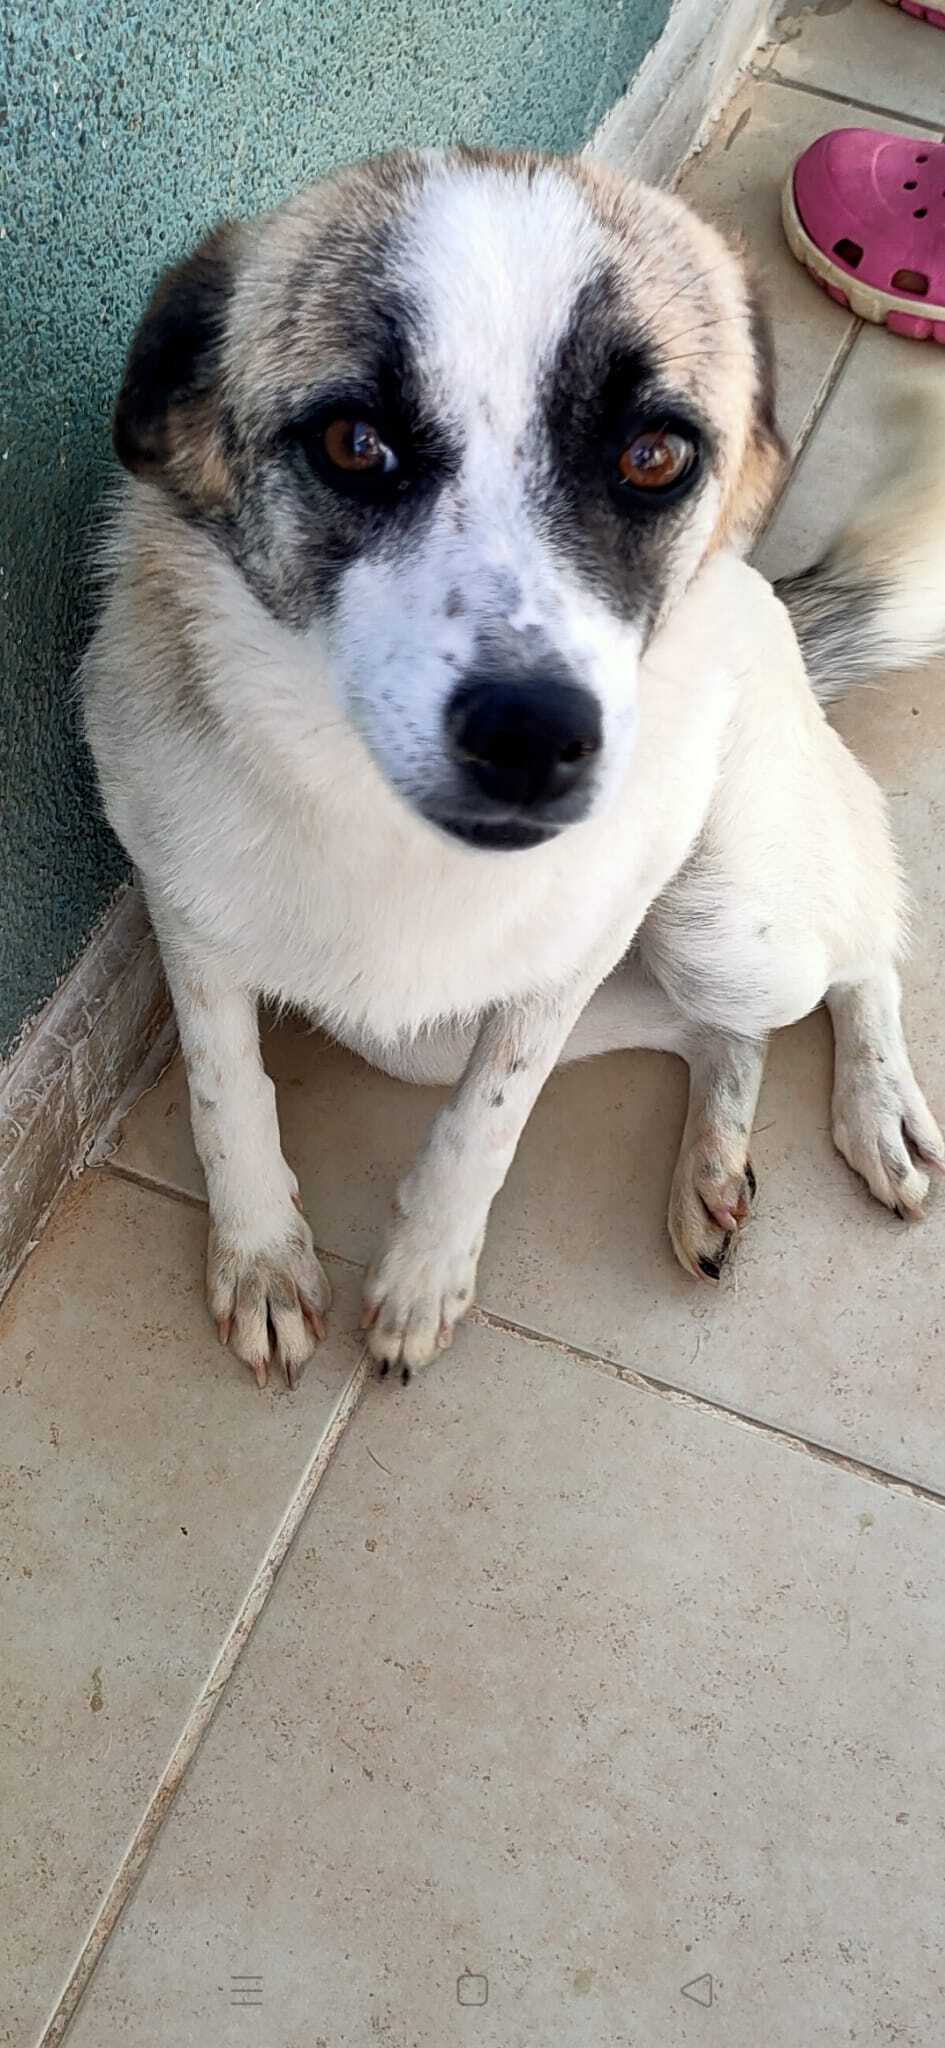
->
[0,0,773,1296]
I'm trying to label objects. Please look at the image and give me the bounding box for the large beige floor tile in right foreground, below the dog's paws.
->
[70,1327,945,2048]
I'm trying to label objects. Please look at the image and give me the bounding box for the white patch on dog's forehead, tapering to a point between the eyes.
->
[389,162,607,432]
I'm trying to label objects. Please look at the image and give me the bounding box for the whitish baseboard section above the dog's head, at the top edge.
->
[586,0,775,184]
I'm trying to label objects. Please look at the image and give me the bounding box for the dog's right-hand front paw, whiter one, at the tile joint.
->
[361,1217,482,1384]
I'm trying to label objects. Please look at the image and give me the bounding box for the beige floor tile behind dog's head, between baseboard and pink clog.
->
[679,80,853,446]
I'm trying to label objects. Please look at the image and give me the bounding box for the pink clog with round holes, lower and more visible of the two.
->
[781,128,945,342]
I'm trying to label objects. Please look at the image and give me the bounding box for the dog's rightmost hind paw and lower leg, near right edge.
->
[826,963,945,1217]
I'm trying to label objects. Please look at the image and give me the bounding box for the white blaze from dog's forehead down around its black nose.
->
[317,160,642,813]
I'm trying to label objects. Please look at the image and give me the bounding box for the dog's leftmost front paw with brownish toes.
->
[207,1210,332,1386]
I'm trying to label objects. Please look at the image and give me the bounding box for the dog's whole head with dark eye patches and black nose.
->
[115,152,781,848]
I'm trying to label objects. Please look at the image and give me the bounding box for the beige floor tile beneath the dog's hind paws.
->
[485,978,945,1489]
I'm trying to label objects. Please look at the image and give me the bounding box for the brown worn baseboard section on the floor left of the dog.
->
[0,885,174,1296]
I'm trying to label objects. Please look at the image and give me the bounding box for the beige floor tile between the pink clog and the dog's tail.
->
[754,315,945,578]
